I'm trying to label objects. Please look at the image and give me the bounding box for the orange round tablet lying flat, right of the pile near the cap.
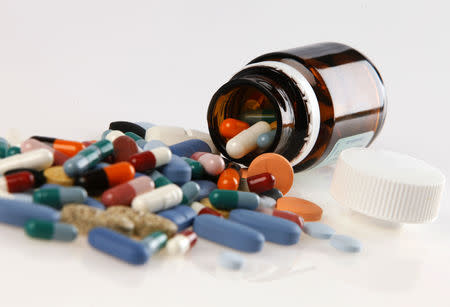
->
[276,197,323,222]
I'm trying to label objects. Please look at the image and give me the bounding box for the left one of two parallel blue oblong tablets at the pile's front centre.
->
[194,214,264,253]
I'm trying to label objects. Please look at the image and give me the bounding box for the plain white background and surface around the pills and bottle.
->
[0,0,450,307]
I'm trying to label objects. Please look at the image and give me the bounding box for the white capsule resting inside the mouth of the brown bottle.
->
[226,121,271,159]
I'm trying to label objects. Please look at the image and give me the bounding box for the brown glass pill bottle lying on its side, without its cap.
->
[207,43,386,171]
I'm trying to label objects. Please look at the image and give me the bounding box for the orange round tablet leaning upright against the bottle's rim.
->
[247,153,294,195]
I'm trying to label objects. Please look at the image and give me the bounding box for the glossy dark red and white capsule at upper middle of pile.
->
[128,147,172,172]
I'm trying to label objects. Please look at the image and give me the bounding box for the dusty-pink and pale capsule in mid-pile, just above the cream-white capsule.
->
[102,176,155,207]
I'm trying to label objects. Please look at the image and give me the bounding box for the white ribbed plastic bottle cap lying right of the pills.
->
[331,148,445,223]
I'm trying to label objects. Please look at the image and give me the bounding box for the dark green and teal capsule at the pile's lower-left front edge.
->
[25,220,78,242]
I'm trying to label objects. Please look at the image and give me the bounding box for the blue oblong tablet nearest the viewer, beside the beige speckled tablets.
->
[88,227,150,264]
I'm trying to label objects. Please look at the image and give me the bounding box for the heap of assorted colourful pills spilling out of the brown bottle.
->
[0,121,360,268]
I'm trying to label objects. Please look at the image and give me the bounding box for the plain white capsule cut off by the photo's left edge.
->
[0,149,53,175]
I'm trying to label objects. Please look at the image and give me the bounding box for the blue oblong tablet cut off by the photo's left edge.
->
[0,198,60,227]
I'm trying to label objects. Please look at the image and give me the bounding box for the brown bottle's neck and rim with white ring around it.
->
[208,61,320,166]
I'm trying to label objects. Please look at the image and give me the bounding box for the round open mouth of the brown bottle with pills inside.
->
[208,78,281,165]
